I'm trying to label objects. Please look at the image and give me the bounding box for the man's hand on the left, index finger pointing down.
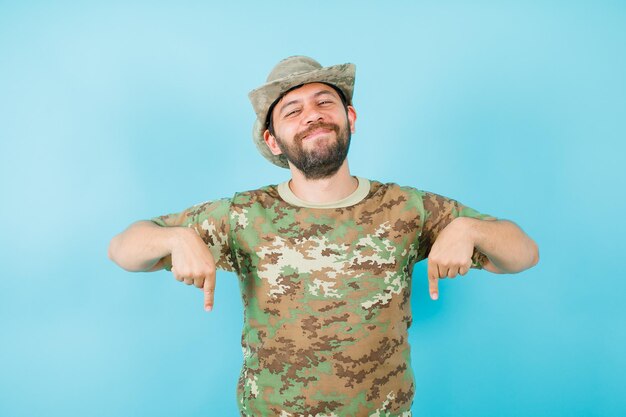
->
[172,227,216,311]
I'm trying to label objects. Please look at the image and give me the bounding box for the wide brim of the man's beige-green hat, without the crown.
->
[248,64,356,168]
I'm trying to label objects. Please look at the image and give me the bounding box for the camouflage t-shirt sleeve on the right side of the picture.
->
[419,192,496,269]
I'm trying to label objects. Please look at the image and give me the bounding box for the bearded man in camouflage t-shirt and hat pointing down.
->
[109,56,538,417]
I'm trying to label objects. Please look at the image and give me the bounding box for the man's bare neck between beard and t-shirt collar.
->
[289,159,359,204]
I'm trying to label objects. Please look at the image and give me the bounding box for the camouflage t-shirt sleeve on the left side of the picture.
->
[150,198,235,271]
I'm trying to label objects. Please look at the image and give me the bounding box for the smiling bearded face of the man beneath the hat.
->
[265,83,356,179]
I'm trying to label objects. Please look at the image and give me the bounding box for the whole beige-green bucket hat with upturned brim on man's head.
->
[248,56,356,168]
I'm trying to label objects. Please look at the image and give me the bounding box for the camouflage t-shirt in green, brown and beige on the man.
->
[153,178,489,417]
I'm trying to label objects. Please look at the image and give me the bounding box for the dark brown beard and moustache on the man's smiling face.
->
[276,122,352,180]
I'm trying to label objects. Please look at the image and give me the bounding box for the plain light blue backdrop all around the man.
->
[0,1,626,417]
